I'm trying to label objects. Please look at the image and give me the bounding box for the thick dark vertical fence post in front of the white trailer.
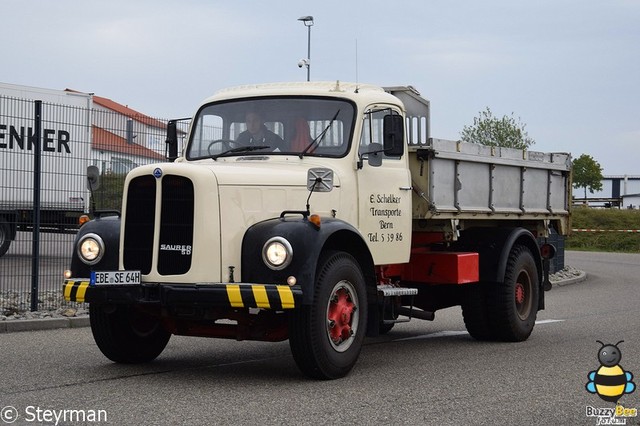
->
[31,101,42,312]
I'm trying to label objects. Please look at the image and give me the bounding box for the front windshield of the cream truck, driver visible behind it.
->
[187,97,354,160]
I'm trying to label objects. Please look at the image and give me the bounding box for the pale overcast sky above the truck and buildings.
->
[0,0,640,175]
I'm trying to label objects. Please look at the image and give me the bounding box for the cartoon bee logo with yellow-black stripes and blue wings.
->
[585,340,636,403]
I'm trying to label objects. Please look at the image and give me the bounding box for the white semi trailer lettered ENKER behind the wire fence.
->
[0,83,92,256]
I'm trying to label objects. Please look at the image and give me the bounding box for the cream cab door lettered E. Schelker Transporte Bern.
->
[356,106,412,265]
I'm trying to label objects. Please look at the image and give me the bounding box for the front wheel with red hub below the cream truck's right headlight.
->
[289,251,367,379]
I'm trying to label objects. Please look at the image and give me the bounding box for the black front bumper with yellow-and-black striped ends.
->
[64,279,302,310]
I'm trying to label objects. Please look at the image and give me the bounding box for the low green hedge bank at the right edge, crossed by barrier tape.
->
[566,207,640,253]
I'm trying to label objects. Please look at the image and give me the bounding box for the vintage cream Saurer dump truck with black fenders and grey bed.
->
[64,82,571,379]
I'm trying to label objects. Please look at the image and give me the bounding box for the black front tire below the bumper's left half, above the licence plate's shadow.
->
[89,303,171,364]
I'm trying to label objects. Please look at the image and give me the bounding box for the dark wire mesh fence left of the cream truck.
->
[0,96,175,316]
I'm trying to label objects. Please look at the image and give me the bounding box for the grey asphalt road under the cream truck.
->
[0,252,640,425]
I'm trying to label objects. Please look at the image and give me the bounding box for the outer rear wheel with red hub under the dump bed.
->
[490,245,540,342]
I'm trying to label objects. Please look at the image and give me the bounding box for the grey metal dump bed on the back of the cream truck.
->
[409,139,571,231]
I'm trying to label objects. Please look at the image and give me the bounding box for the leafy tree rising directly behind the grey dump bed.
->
[460,107,535,149]
